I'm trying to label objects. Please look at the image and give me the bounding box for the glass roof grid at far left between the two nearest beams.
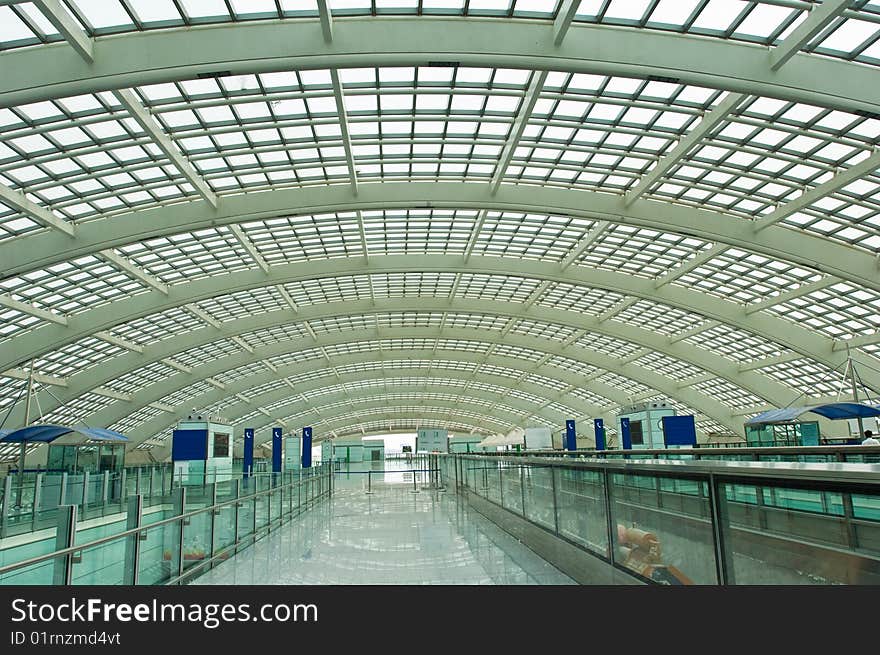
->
[0,92,194,238]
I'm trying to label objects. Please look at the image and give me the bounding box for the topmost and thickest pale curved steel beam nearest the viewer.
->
[0,16,880,113]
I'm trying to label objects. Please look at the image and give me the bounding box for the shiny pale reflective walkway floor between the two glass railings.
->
[192,462,574,585]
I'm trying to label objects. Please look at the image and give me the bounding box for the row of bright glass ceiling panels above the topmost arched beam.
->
[8,0,880,70]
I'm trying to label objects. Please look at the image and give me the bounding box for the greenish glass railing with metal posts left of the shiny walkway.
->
[0,464,332,585]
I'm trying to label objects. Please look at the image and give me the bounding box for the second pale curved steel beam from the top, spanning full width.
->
[0,182,880,291]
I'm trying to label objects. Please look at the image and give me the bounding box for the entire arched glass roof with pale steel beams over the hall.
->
[0,0,880,456]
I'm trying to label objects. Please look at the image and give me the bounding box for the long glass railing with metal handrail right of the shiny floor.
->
[439,455,880,585]
